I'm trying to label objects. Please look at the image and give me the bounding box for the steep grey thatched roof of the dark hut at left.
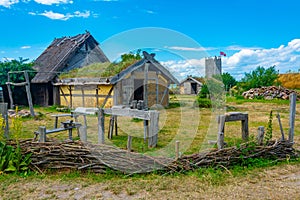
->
[31,32,109,83]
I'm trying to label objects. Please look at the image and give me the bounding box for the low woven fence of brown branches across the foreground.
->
[10,140,299,174]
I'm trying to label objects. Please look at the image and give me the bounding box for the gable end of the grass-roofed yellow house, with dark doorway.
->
[110,51,179,107]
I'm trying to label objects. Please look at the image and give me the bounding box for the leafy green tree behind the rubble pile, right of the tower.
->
[241,66,278,90]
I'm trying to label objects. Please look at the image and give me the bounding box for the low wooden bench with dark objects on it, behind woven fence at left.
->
[34,120,81,142]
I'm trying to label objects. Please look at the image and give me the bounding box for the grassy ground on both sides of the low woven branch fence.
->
[0,96,300,199]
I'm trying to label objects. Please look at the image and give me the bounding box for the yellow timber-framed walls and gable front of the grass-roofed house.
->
[54,52,178,108]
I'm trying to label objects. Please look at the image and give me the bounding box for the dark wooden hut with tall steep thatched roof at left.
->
[31,32,109,106]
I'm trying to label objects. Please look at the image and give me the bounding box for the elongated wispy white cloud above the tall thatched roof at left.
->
[28,10,90,21]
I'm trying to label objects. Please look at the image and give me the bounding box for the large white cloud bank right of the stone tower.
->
[222,39,300,79]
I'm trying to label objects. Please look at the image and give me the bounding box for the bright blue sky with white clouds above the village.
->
[0,0,300,79]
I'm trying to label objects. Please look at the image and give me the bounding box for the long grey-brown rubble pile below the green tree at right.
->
[242,86,300,100]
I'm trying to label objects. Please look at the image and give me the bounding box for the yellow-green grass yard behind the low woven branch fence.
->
[14,95,300,157]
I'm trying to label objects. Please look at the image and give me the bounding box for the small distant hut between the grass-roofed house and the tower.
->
[179,76,202,94]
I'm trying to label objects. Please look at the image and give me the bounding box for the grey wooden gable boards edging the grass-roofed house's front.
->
[110,51,179,85]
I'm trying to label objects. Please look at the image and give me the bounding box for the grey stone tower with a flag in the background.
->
[205,56,222,78]
